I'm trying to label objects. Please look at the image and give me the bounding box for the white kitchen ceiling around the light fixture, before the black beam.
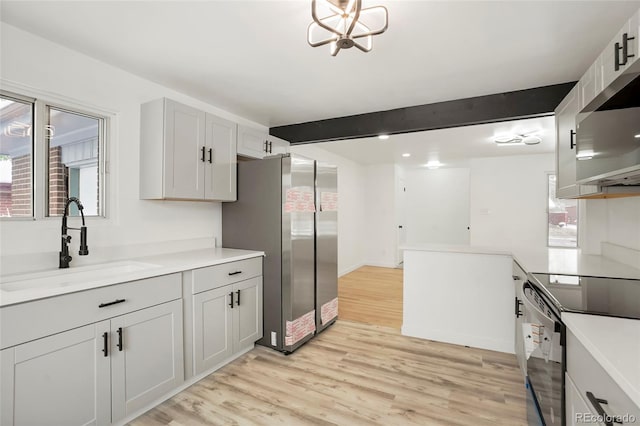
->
[0,0,640,126]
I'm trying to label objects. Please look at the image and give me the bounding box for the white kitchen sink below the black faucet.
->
[0,261,160,292]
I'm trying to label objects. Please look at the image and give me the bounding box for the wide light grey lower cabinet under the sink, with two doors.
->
[0,274,184,426]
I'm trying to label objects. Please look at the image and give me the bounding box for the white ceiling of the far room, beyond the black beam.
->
[315,116,556,167]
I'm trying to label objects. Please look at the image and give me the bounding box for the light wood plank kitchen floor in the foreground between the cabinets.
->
[131,319,526,426]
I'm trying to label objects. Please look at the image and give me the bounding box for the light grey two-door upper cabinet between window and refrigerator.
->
[140,98,237,201]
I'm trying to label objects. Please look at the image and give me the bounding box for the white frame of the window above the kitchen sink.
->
[0,89,109,221]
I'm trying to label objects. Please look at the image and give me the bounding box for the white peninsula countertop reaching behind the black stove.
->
[400,244,640,279]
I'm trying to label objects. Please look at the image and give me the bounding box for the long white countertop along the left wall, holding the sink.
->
[0,248,264,307]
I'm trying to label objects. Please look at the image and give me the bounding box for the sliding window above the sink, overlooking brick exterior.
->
[0,93,107,218]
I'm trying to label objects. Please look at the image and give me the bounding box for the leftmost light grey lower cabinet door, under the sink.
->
[0,321,111,426]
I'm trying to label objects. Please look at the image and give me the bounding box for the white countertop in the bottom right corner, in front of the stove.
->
[562,312,640,407]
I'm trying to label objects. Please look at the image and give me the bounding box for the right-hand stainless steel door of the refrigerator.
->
[316,162,338,332]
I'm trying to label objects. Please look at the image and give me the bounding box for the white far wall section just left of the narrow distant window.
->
[470,154,555,249]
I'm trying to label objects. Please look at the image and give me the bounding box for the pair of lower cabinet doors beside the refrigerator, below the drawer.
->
[193,276,262,375]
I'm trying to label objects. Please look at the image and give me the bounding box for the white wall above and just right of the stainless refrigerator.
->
[291,145,366,276]
